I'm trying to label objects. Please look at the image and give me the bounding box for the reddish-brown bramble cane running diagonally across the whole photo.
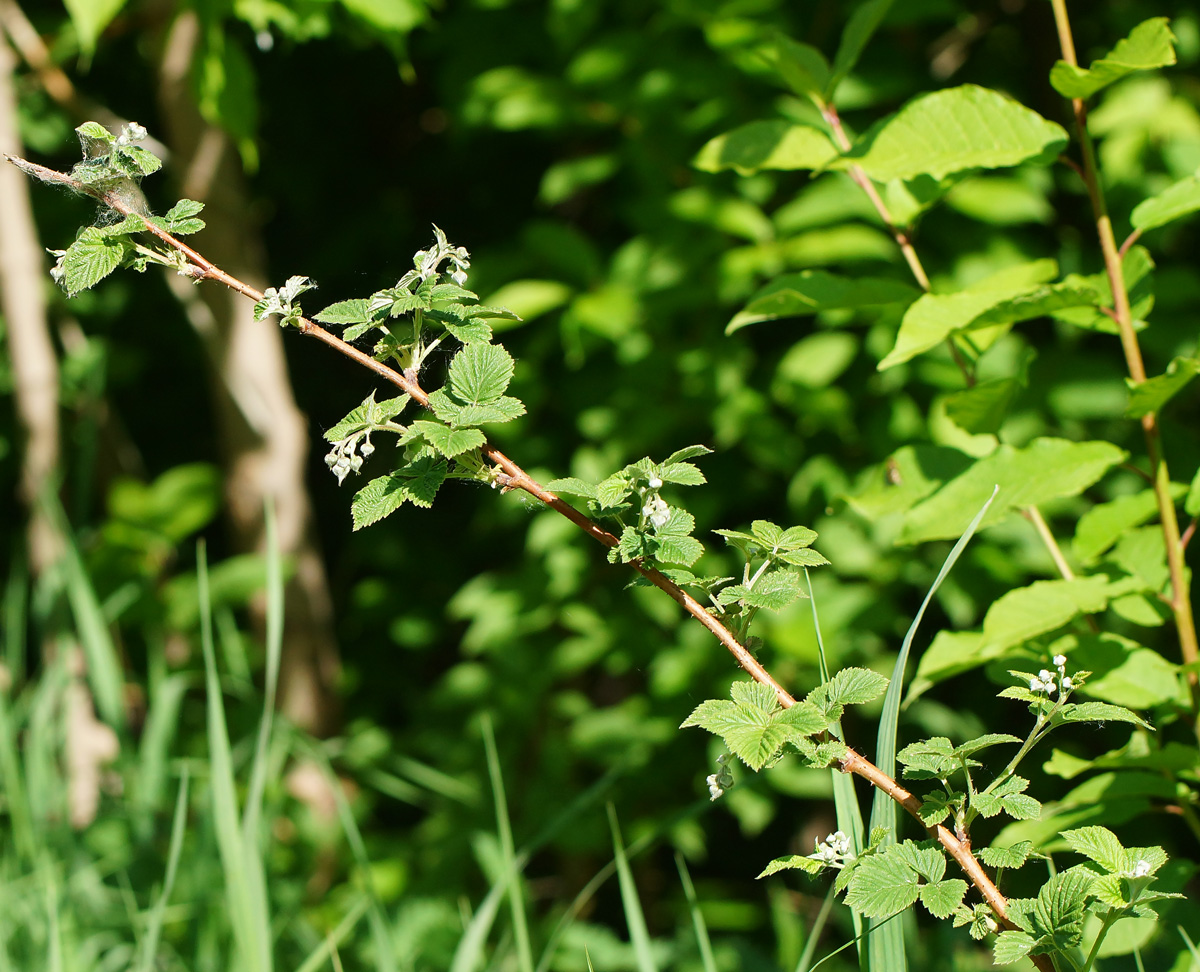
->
[5,155,1054,972]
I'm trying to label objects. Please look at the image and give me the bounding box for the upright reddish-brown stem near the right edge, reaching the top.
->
[1051,0,1200,707]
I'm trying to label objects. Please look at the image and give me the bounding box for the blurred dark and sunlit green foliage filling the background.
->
[7,0,1200,970]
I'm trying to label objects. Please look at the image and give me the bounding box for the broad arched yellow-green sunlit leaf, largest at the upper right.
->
[830,84,1067,182]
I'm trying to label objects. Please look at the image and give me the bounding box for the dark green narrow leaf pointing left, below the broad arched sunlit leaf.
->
[725,270,920,334]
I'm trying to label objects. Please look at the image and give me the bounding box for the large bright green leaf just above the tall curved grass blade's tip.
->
[899,438,1127,544]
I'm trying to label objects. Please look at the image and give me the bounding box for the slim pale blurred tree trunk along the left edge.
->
[0,36,61,574]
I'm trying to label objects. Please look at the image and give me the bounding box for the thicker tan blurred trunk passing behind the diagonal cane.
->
[158,11,340,733]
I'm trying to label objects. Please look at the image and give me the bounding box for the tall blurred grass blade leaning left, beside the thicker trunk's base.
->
[197,541,271,972]
